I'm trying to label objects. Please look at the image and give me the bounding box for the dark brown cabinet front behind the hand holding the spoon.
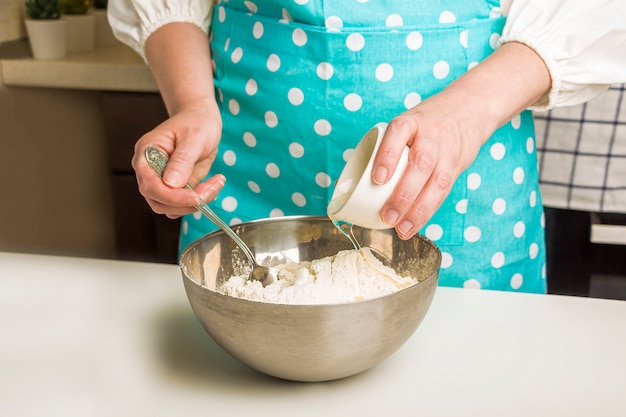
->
[102,92,180,263]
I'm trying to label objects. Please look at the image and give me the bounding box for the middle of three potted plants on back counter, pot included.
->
[60,0,96,54]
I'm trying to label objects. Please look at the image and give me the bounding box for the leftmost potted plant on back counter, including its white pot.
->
[25,0,67,59]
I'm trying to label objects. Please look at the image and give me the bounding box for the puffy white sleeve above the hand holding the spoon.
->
[107,0,215,61]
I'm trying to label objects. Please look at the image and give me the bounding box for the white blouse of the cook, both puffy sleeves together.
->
[108,0,626,110]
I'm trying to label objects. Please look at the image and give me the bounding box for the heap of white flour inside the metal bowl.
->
[219,248,417,304]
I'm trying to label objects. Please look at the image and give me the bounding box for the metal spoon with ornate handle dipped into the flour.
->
[146,146,278,287]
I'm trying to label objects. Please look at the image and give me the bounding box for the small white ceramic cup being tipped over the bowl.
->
[328,123,409,229]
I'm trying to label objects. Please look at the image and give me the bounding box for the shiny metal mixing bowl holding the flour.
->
[180,216,441,381]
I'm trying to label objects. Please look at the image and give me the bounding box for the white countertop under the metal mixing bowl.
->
[0,253,626,417]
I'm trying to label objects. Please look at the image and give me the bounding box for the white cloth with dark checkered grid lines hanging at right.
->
[535,84,626,213]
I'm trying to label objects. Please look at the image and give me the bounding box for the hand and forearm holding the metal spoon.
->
[132,22,225,218]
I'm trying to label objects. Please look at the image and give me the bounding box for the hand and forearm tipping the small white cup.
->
[372,42,551,239]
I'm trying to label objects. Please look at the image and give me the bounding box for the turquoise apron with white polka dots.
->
[181,0,546,292]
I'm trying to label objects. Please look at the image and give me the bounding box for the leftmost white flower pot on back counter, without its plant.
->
[25,19,67,59]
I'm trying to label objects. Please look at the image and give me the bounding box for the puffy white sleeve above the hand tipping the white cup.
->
[499,0,626,110]
